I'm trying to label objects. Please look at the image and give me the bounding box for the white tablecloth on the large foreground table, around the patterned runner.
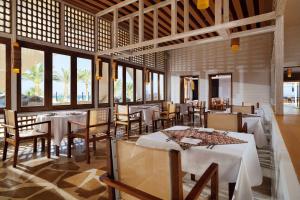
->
[136,126,262,200]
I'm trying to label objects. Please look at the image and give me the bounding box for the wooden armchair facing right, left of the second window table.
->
[114,104,142,139]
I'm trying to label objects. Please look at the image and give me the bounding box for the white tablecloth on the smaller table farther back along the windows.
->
[129,105,159,126]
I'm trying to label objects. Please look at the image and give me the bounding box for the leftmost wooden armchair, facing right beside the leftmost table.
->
[1,109,51,167]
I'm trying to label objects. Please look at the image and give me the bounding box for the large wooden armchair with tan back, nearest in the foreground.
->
[100,139,219,200]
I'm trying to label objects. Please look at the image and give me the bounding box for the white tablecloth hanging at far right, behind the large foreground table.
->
[243,117,268,148]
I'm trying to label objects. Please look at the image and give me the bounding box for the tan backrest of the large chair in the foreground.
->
[116,140,183,199]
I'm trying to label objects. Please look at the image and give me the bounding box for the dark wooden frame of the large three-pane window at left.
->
[17,41,95,112]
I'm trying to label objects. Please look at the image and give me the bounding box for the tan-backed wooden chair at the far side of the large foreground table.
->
[204,112,247,133]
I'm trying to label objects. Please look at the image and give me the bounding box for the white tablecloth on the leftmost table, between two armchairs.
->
[35,112,86,146]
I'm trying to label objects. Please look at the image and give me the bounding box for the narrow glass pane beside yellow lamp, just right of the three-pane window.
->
[99,62,109,103]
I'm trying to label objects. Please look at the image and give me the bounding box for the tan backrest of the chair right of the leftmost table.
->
[87,108,110,133]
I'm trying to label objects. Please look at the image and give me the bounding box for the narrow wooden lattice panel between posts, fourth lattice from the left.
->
[98,18,111,51]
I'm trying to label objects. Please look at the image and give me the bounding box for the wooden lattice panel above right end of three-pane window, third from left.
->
[65,5,95,51]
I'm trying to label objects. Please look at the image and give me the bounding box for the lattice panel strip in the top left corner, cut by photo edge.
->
[0,0,11,33]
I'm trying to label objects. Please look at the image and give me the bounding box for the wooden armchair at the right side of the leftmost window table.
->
[68,108,110,164]
